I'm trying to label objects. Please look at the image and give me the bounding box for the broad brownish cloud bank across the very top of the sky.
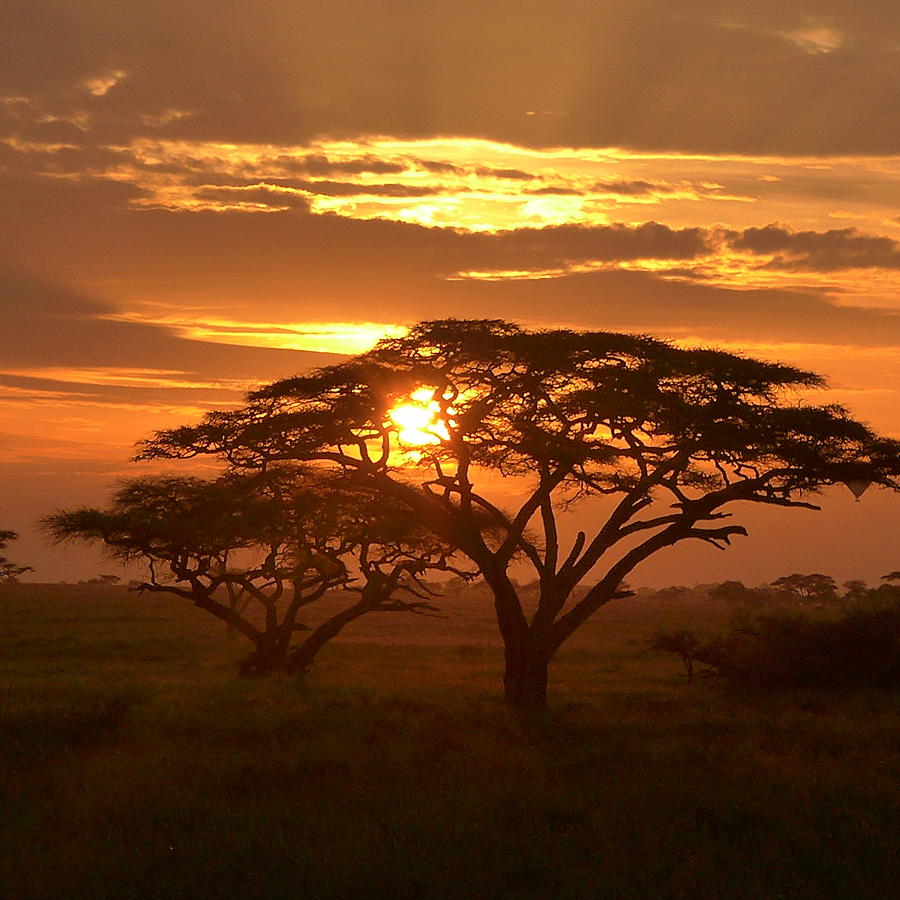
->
[0,0,900,153]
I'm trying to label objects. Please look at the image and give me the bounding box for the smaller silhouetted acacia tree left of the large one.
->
[42,467,470,675]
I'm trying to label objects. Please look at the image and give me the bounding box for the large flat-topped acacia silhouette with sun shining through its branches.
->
[141,320,900,706]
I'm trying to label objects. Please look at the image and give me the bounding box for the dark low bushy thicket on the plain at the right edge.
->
[651,592,900,690]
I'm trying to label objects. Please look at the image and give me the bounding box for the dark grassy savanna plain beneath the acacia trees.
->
[0,585,900,900]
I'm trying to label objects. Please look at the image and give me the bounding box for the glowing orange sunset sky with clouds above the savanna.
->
[0,0,900,585]
